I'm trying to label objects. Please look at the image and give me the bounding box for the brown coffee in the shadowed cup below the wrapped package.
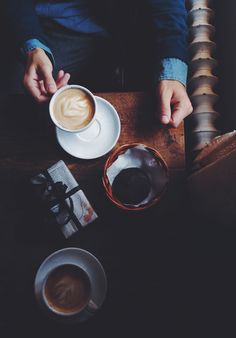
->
[45,264,91,314]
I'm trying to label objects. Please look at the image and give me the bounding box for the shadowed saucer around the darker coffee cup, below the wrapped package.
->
[34,247,107,322]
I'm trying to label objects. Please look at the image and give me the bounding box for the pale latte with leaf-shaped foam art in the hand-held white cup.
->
[53,88,95,131]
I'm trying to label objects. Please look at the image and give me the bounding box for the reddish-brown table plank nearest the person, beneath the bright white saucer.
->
[0,92,185,178]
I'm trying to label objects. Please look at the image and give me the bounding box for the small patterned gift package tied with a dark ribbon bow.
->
[31,161,98,238]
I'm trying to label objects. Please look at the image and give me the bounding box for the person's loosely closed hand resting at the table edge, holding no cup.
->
[156,80,193,128]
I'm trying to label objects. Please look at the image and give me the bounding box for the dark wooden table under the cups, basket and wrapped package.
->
[0,93,187,338]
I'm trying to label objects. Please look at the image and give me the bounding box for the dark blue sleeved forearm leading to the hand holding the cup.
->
[2,0,45,47]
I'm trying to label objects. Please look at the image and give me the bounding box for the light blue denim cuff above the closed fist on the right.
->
[157,58,188,86]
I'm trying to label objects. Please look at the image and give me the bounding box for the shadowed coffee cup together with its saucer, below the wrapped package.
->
[34,247,107,323]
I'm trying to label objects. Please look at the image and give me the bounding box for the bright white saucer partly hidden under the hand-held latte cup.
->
[56,96,120,159]
